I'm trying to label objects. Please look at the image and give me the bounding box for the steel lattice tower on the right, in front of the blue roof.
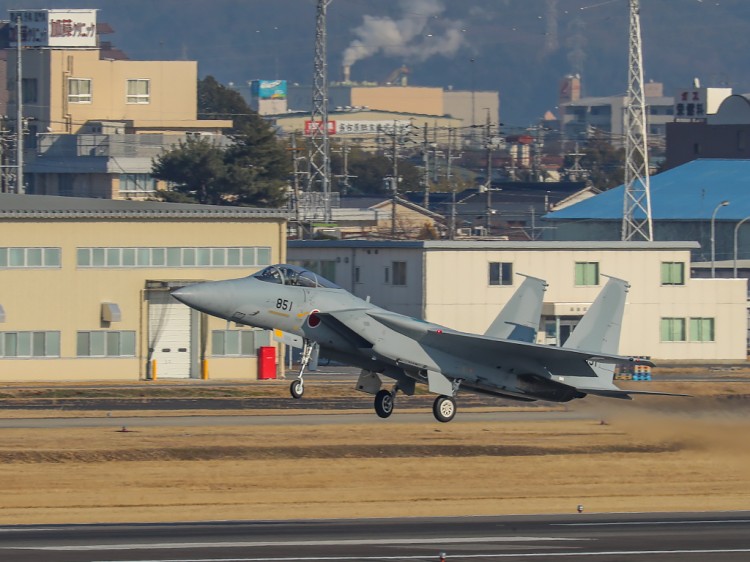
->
[622,0,654,238]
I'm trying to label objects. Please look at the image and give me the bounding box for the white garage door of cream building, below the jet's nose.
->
[148,291,192,378]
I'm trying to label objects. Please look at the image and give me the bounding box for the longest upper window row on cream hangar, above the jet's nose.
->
[78,246,271,268]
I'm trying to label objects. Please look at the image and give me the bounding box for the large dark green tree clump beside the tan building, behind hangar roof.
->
[151,76,289,207]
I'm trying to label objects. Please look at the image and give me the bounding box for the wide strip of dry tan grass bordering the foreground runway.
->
[0,382,750,524]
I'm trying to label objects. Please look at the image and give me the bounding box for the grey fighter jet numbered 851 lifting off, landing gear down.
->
[172,264,672,422]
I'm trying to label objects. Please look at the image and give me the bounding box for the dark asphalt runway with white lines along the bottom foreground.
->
[0,512,750,562]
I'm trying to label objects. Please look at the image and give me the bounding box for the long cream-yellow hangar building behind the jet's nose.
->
[0,194,287,381]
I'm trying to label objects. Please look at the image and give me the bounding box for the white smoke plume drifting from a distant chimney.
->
[343,0,464,66]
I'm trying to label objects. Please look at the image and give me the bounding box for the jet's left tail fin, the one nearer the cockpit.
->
[484,274,547,343]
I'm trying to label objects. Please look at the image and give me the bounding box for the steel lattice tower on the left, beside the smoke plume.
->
[308,0,332,222]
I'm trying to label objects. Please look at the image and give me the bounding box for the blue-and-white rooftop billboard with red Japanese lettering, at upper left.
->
[10,10,96,47]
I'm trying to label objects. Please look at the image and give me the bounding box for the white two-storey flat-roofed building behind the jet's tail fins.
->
[287,240,747,361]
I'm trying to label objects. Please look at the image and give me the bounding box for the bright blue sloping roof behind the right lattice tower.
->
[544,159,750,221]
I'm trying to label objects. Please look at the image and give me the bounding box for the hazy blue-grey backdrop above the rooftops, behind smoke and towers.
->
[0,0,750,124]
